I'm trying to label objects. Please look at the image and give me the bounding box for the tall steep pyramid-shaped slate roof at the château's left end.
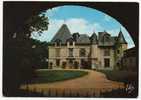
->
[51,24,71,43]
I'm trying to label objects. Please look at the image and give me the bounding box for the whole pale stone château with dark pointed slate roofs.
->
[48,24,127,70]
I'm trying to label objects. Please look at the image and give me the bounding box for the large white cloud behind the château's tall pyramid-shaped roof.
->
[32,18,102,41]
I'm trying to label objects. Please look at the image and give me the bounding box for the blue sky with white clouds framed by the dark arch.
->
[31,5,135,48]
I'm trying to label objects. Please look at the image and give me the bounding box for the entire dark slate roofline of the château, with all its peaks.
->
[50,24,127,46]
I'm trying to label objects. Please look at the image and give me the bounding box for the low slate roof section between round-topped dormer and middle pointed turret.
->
[76,34,90,44]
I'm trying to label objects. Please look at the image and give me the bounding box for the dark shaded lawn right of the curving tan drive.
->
[98,70,137,83]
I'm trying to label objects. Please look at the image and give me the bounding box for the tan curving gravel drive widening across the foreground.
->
[21,69,124,96]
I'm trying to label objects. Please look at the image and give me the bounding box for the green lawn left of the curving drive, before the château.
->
[31,70,88,83]
